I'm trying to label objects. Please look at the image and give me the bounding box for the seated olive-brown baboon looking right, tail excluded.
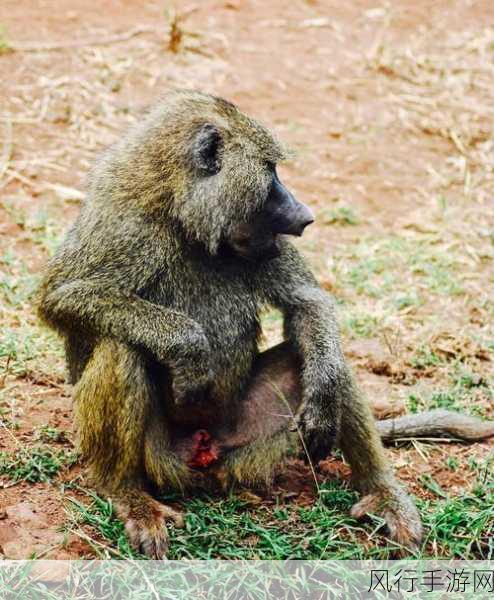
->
[39,90,470,558]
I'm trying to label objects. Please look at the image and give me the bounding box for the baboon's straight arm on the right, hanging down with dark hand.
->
[266,244,351,460]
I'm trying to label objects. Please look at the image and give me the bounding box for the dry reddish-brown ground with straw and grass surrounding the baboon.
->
[0,0,494,558]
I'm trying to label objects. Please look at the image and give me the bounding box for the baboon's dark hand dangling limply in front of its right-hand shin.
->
[297,403,338,463]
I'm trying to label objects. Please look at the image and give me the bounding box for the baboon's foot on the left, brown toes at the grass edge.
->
[115,491,184,559]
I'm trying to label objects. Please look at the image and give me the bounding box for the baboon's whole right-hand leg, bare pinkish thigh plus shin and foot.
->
[225,343,422,548]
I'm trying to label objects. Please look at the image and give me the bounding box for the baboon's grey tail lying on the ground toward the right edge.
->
[377,408,494,442]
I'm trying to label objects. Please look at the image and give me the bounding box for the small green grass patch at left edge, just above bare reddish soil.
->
[0,445,77,483]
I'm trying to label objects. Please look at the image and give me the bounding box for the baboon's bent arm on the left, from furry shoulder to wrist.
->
[39,210,208,365]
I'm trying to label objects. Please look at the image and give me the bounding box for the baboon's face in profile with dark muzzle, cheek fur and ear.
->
[184,113,314,261]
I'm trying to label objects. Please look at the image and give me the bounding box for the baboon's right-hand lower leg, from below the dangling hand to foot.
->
[339,383,422,549]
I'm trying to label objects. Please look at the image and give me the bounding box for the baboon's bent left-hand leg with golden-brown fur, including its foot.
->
[74,340,186,558]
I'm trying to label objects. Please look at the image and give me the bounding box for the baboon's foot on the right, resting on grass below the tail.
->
[351,484,422,554]
